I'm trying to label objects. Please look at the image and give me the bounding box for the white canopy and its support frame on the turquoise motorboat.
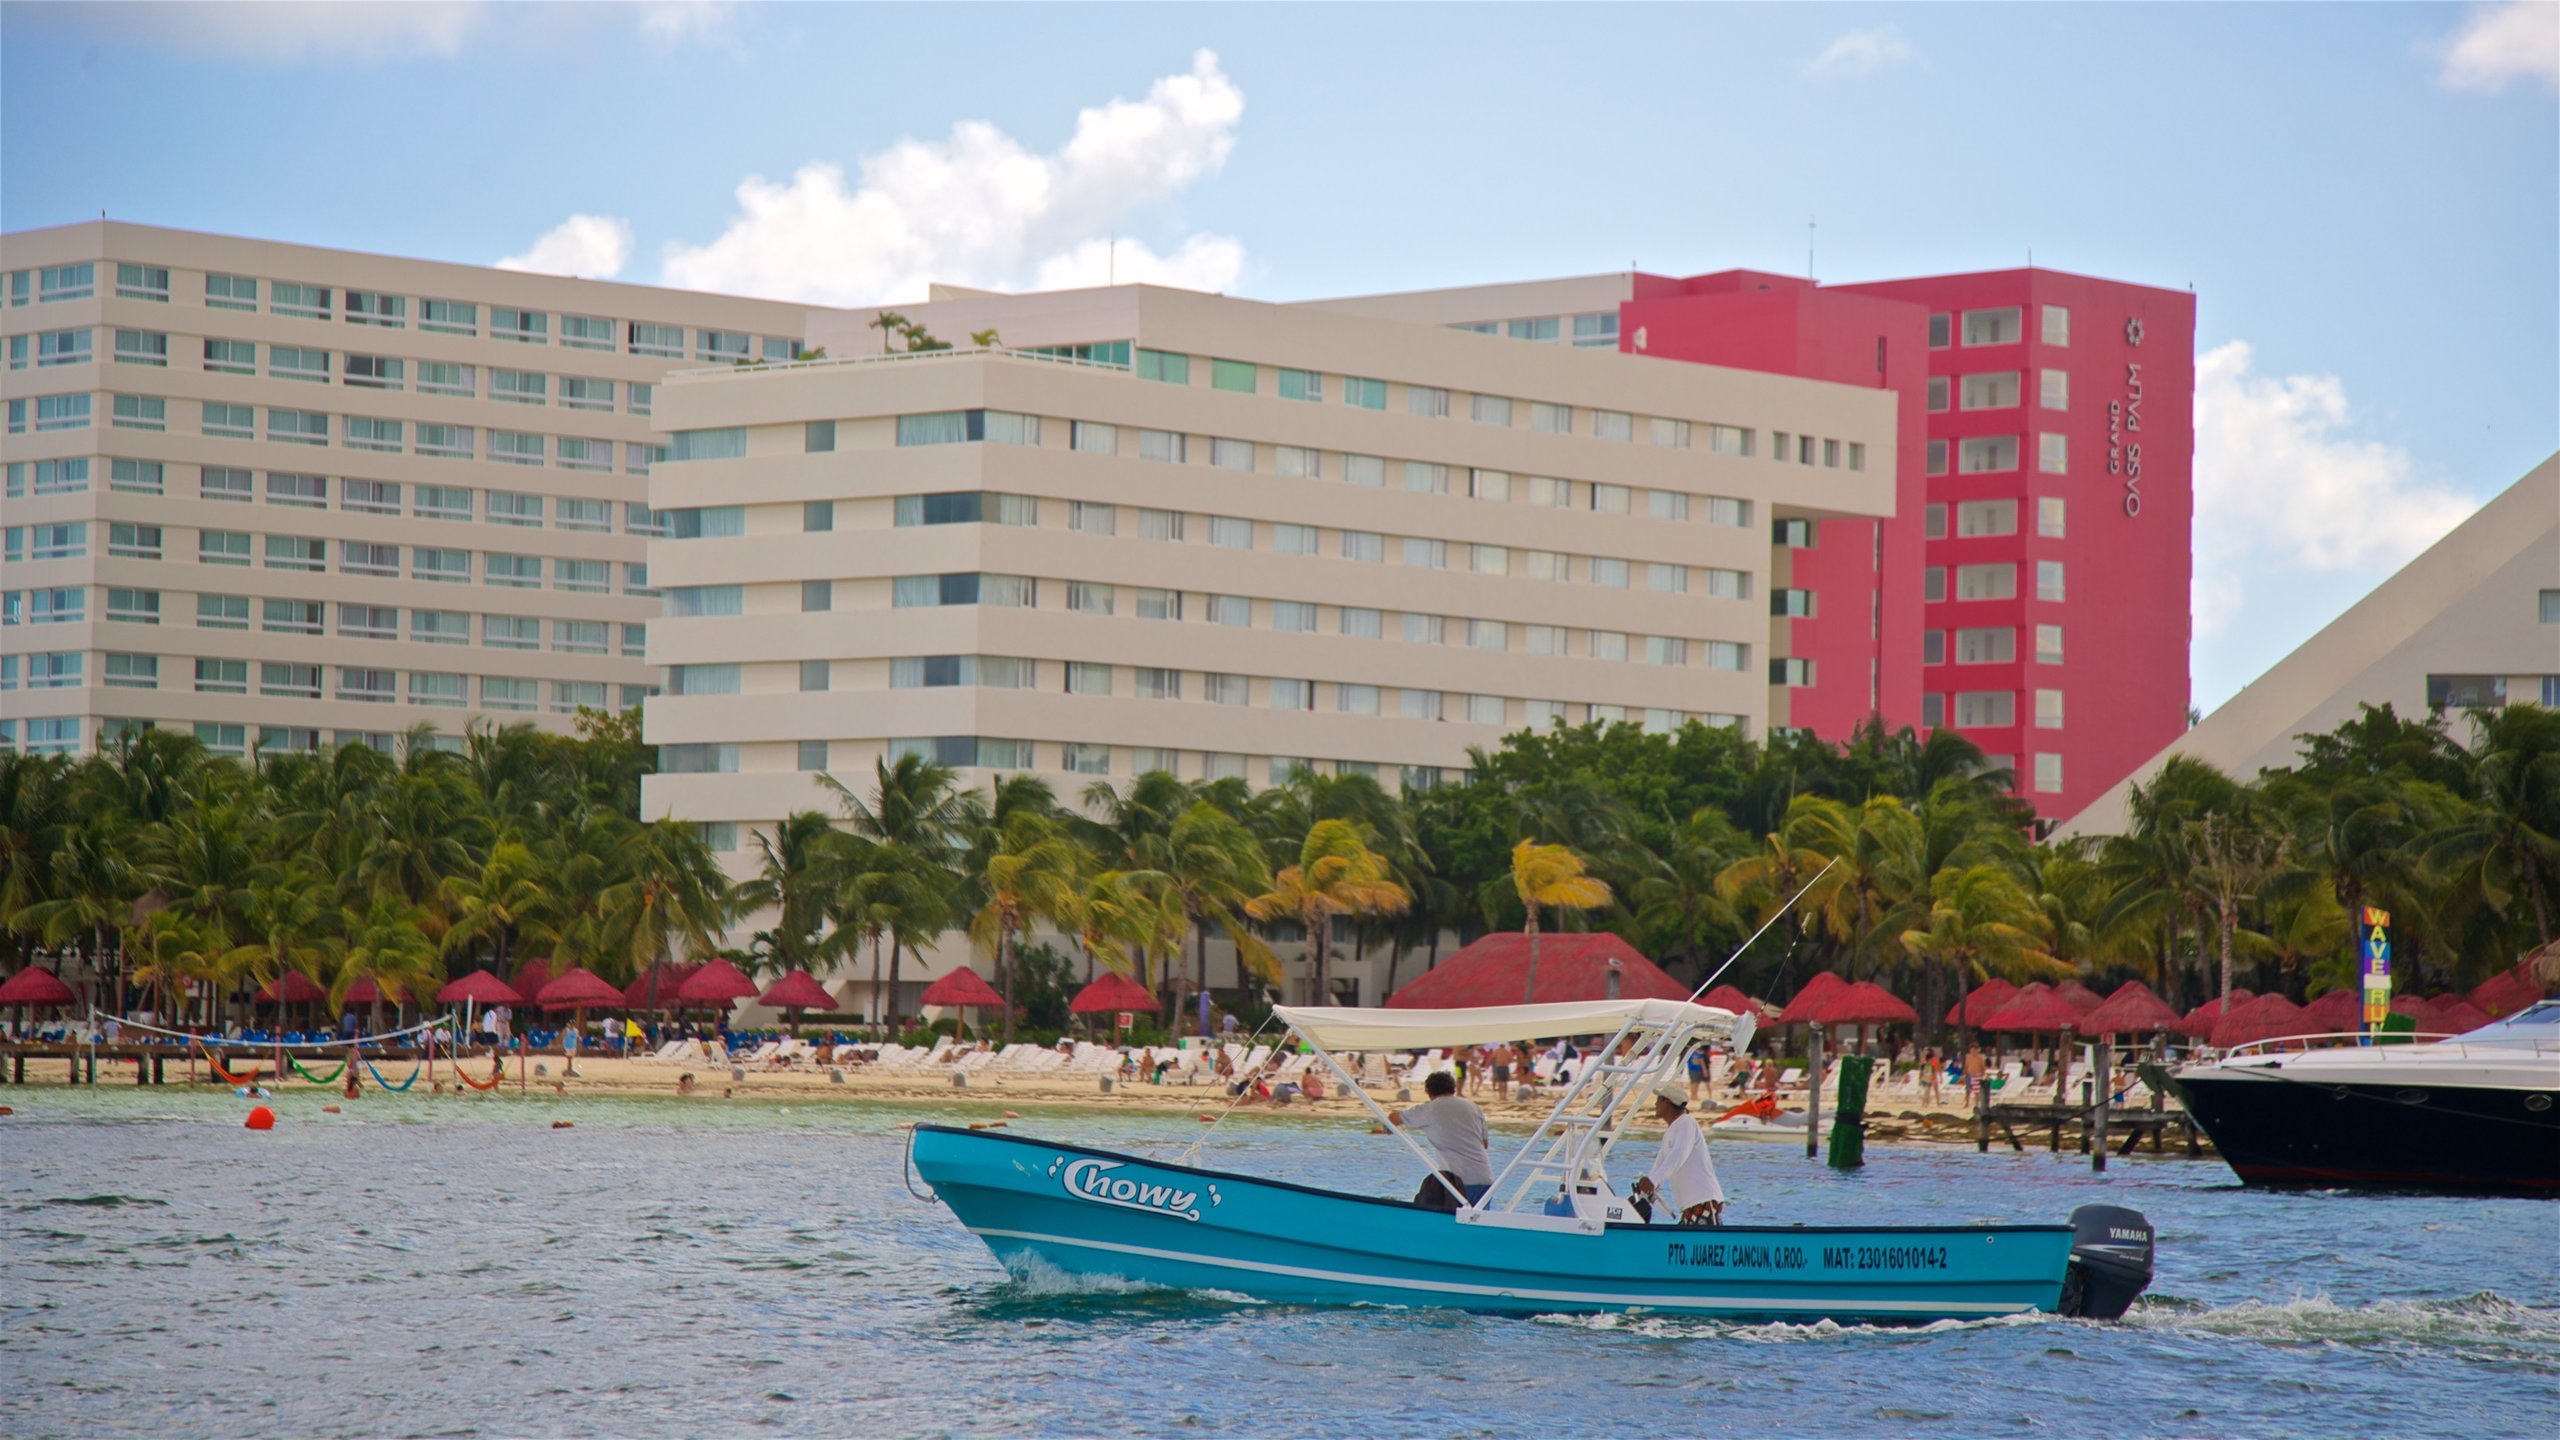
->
[1272,999,1756,1219]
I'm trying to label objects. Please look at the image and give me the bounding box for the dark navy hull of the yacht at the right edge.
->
[2176,1068,2560,1197]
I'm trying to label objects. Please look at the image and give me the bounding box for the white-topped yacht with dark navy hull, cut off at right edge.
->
[2173,999,2560,1197]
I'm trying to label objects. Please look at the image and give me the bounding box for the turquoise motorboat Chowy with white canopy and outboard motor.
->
[909,999,2150,1325]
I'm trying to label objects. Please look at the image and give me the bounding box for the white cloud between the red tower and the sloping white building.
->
[2191,341,2478,638]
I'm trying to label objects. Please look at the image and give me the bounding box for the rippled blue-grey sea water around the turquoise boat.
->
[0,1089,2560,1437]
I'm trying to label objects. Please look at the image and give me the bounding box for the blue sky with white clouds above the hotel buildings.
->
[0,0,2560,710]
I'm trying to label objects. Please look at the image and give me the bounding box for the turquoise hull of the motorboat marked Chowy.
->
[911,1125,2074,1325]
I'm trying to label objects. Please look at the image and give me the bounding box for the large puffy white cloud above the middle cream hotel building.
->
[660,51,1244,305]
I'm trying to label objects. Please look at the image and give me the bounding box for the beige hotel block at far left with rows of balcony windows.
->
[0,220,804,756]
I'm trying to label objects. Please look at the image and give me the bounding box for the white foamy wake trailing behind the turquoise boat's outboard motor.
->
[2125,1289,2560,1373]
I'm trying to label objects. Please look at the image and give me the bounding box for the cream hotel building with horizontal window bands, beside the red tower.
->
[648,287,1897,843]
